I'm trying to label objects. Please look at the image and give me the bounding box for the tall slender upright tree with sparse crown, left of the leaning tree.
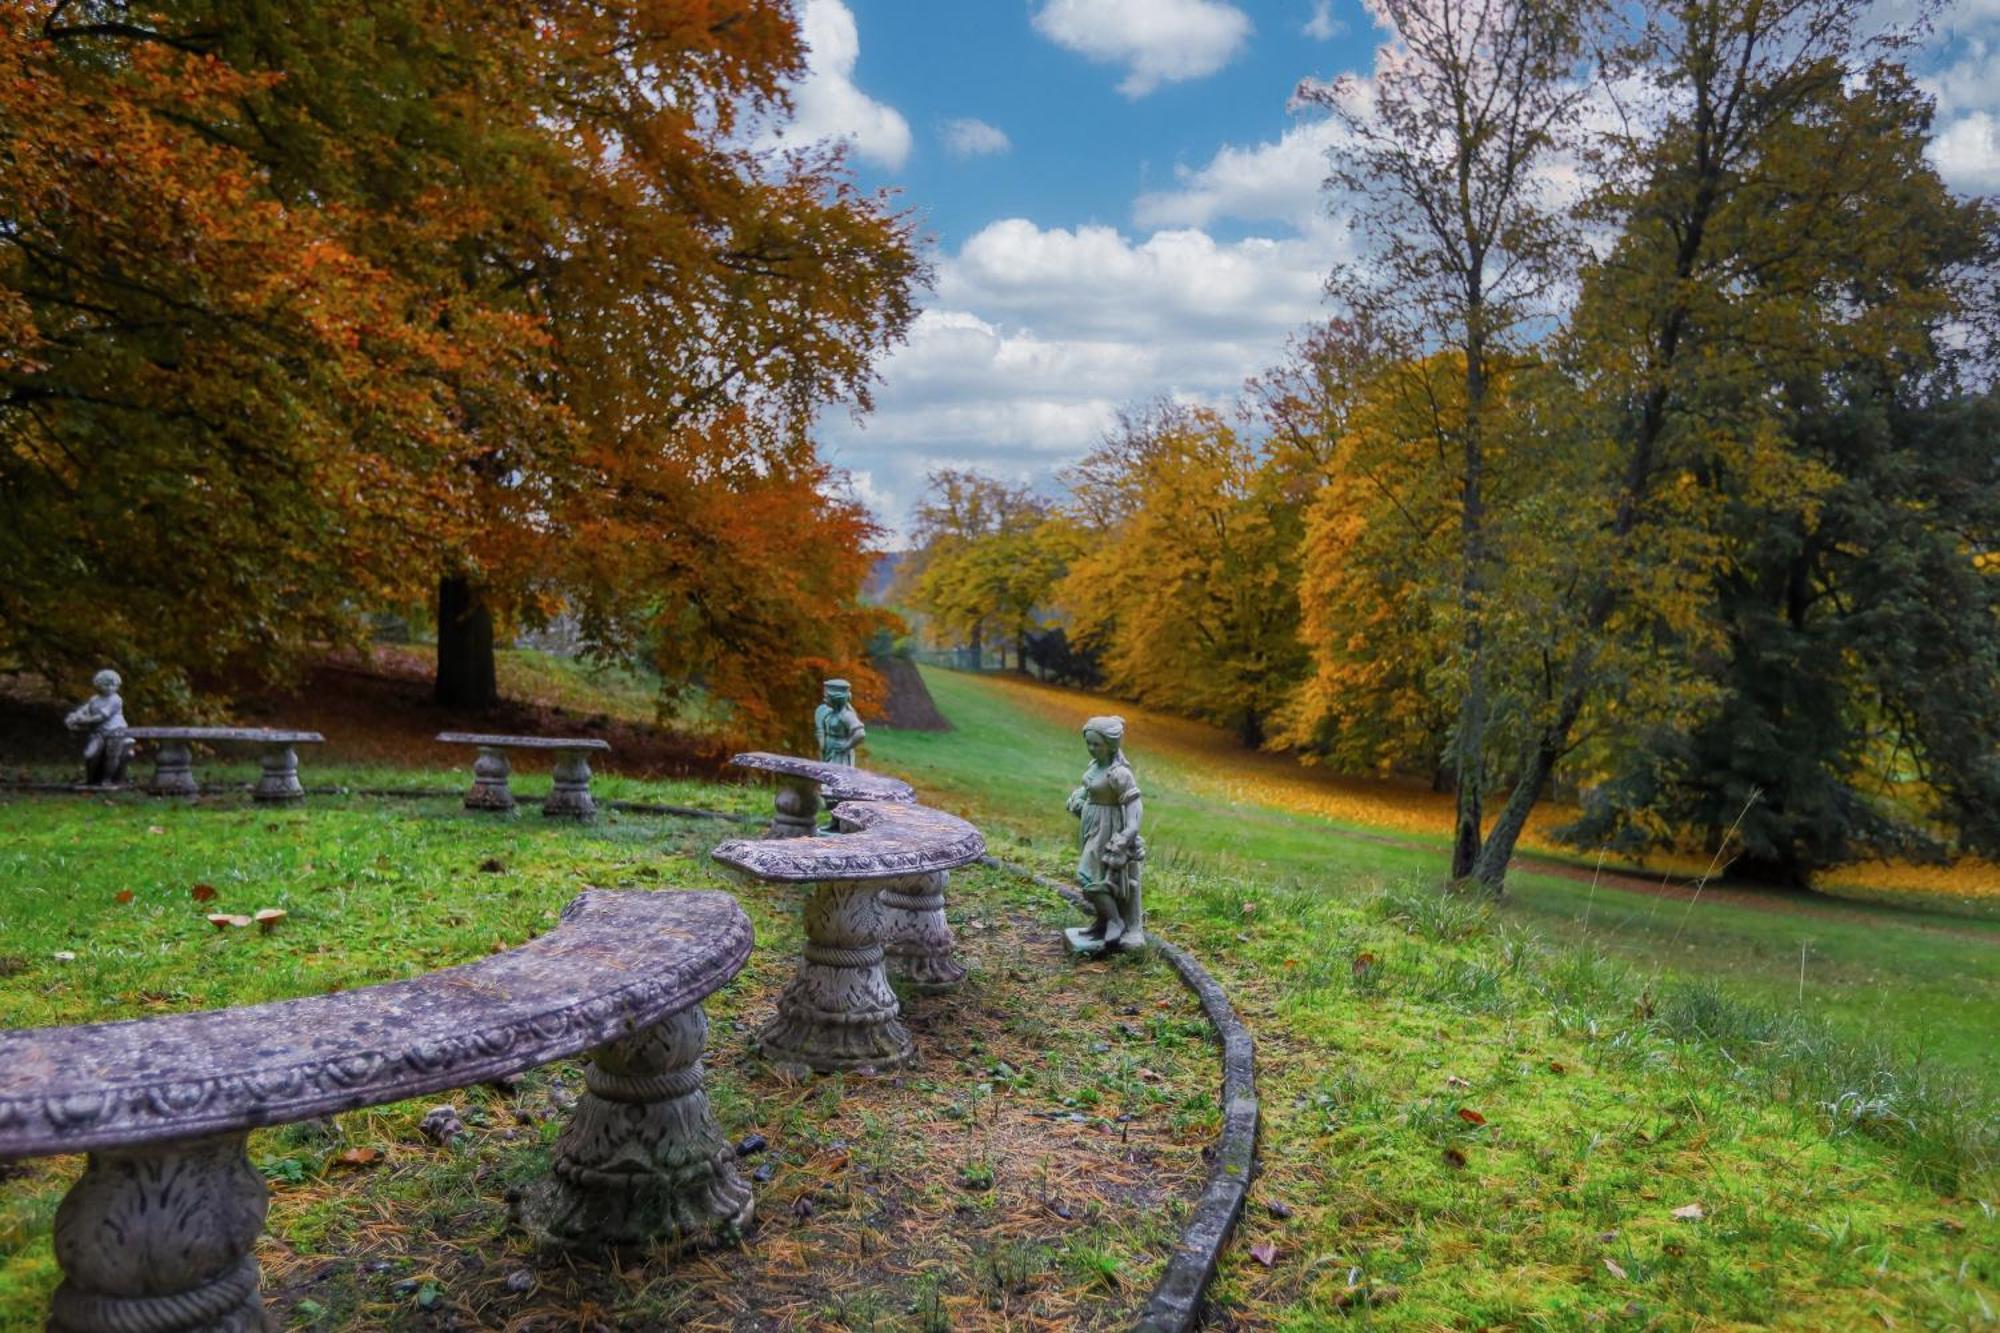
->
[1300,0,1596,879]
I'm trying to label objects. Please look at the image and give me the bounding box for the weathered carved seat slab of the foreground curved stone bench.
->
[0,891,750,1159]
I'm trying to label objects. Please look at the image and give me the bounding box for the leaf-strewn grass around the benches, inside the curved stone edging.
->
[0,784,1220,1331]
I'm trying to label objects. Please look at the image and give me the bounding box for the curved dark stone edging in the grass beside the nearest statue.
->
[982,857,1258,1333]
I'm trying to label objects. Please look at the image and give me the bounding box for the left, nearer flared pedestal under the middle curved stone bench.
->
[756,879,916,1073]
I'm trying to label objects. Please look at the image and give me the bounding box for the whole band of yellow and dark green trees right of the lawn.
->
[900,0,2000,891]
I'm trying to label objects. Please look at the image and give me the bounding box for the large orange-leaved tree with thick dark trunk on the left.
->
[0,0,922,729]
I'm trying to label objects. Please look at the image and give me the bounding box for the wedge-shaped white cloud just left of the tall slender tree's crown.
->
[1132,116,1344,228]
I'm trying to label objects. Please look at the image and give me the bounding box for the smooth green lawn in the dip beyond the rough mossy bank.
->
[868,669,2000,1093]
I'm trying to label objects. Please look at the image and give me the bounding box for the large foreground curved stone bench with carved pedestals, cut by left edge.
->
[0,891,752,1333]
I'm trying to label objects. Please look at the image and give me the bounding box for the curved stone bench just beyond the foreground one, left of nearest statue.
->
[710,801,986,1073]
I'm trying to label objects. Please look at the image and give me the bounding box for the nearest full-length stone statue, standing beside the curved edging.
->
[1064,717,1146,953]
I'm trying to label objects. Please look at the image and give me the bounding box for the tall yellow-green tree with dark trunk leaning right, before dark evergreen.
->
[1474,0,1990,893]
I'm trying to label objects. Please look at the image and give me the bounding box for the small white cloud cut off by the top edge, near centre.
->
[1032,0,1250,98]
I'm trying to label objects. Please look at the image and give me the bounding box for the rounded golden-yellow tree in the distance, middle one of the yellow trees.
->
[1056,404,1304,745]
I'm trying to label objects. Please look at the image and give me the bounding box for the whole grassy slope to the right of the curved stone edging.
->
[870,673,2000,1329]
